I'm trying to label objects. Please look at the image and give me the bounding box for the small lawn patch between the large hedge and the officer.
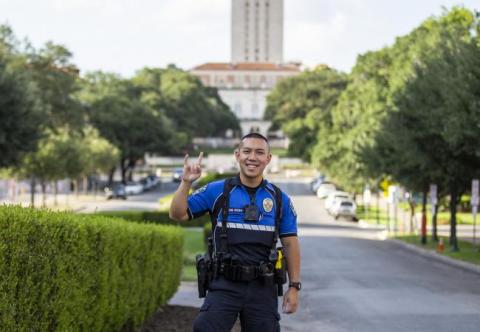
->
[182,228,205,281]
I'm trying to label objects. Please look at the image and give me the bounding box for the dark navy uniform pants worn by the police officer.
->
[193,277,280,332]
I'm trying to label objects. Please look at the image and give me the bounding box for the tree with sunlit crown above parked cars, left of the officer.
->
[79,72,175,182]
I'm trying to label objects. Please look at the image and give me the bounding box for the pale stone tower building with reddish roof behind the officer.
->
[190,0,300,136]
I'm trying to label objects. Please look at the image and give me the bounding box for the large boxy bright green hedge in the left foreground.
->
[0,206,183,331]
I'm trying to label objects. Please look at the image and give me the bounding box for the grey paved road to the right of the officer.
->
[279,179,480,331]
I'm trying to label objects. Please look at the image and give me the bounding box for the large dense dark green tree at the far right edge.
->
[364,8,480,250]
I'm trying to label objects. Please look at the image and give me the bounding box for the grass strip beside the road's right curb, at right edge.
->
[395,235,480,265]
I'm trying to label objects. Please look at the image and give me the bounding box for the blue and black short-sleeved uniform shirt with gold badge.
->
[188,177,297,265]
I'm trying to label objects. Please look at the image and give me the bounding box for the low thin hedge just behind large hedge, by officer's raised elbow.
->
[96,210,211,227]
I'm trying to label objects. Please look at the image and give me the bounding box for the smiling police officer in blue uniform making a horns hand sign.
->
[170,133,301,332]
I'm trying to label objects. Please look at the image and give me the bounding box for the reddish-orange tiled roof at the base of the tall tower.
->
[192,62,300,72]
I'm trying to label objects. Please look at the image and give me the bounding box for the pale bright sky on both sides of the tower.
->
[0,0,480,77]
